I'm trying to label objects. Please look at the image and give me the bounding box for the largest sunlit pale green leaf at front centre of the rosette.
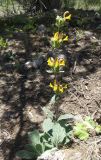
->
[52,123,66,147]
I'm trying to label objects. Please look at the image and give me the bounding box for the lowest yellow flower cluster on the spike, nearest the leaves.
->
[49,79,67,94]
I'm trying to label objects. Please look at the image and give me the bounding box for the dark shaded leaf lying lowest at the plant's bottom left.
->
[16,150,35,159]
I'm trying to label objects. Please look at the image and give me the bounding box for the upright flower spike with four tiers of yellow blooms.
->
[47,11,71,101]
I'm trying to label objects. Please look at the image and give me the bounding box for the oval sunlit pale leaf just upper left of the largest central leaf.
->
[42,118,54,132]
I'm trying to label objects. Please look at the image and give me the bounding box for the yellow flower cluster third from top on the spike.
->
[47,57,65,68]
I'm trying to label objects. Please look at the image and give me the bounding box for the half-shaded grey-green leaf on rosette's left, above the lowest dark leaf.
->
[28,130,40,146]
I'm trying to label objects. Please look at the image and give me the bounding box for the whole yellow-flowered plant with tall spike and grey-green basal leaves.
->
[17,11,73,159]
